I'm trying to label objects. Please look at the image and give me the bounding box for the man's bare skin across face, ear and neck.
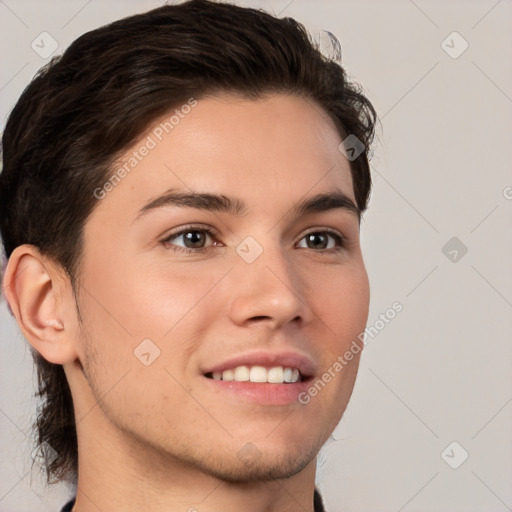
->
[5,94,369,512]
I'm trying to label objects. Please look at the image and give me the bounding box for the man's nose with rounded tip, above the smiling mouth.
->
[230,242,313,330]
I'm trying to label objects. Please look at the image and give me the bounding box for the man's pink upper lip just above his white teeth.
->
[203,351,315,377]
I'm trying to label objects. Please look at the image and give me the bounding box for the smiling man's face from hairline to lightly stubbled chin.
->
[70,95,369,481]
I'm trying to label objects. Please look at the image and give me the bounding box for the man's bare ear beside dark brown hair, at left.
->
[4,244,78,364]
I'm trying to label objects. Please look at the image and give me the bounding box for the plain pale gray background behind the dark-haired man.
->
[0,0,512,512]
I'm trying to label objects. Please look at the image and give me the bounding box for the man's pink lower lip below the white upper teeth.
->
[205,377,310,405]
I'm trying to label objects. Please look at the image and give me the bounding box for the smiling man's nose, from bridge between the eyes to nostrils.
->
[232,233,309,325]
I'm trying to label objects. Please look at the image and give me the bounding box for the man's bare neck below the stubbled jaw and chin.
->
[73,407,316,512]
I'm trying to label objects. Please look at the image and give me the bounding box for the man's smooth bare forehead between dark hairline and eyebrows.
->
[89,94,354,224]
